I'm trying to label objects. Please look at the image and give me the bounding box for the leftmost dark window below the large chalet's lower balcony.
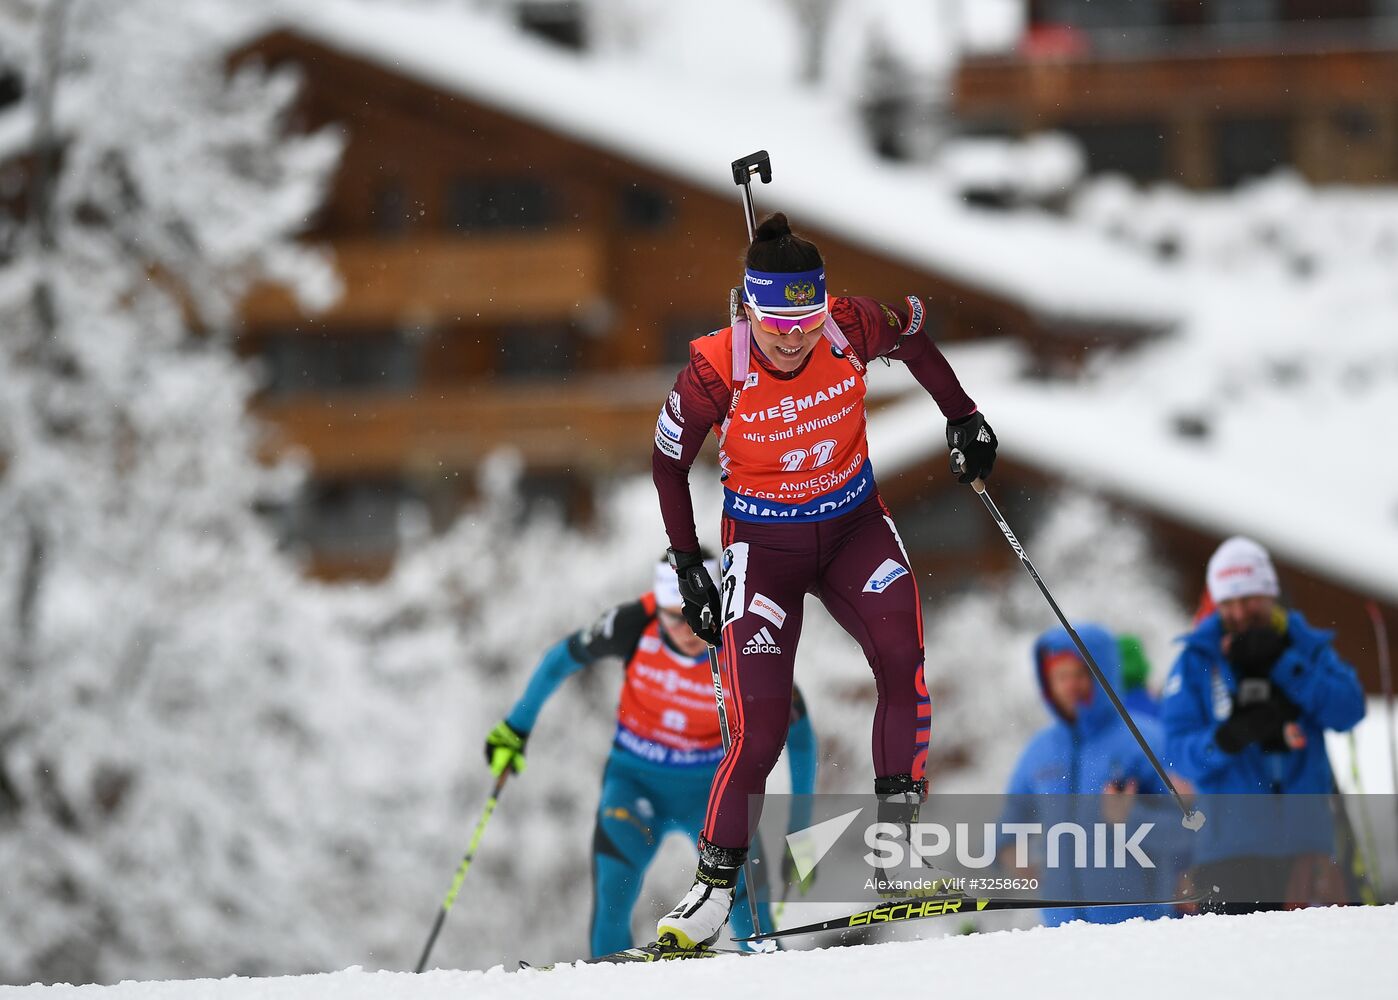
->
[289,478,419,555]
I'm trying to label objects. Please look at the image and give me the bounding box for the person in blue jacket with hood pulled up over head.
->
[1001,624,1187,927]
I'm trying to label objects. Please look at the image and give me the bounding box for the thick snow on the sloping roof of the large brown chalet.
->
[262,0,1179,326]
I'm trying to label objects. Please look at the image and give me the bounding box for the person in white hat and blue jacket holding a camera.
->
[1162,537,1364,912]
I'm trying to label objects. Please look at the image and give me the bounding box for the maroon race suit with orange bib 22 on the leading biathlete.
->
[651,297,976,848]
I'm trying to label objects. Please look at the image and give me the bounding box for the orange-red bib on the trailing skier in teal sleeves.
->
[615,621,723,768]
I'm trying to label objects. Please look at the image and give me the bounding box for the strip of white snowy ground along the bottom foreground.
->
[19,906,1398,1000]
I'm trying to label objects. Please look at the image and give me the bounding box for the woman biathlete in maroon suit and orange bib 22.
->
[653,214,995,948]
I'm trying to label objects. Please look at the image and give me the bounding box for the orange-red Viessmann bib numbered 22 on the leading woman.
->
[705,320,874,523]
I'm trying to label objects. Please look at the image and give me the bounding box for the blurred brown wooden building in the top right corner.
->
[953,0,1398,187]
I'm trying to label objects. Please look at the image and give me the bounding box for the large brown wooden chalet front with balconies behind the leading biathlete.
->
[239,23,1134,575]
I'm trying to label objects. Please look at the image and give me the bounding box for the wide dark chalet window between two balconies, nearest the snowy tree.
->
[261,331,421,396]
